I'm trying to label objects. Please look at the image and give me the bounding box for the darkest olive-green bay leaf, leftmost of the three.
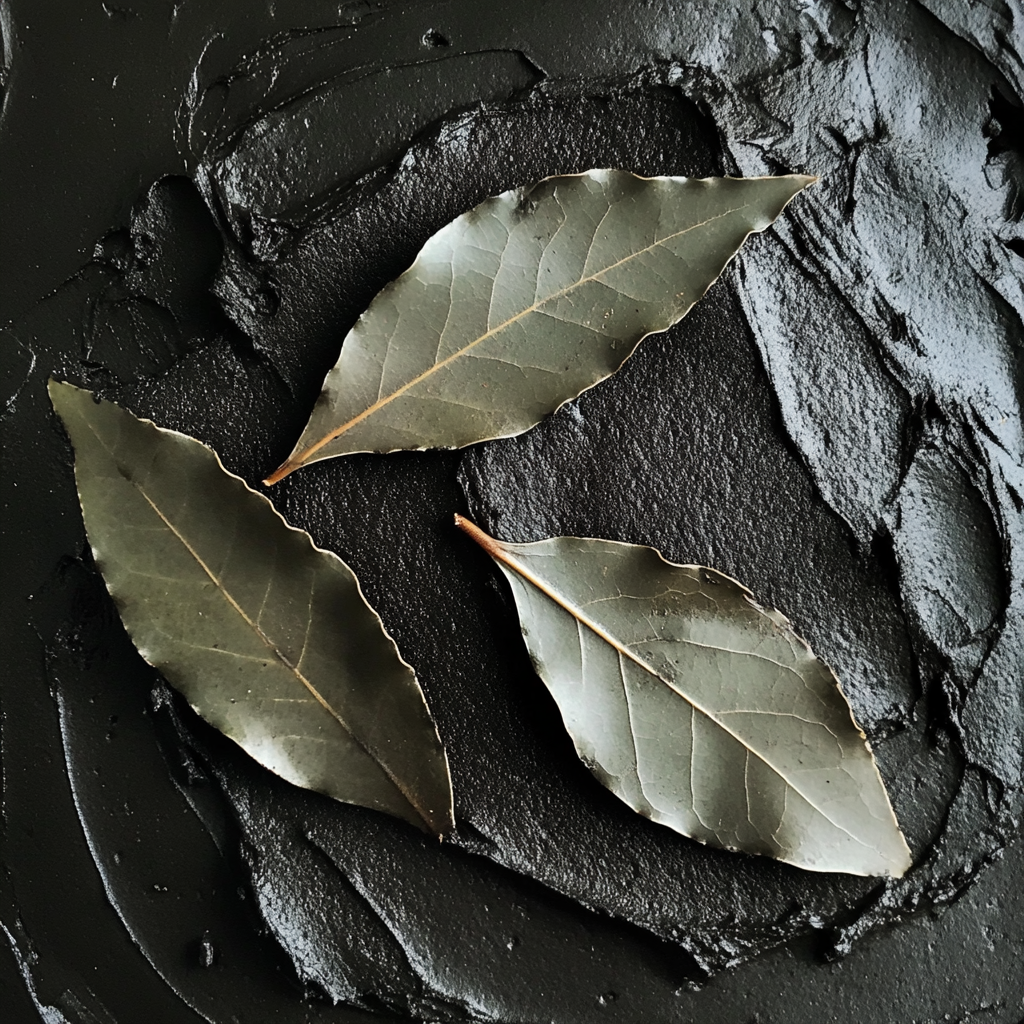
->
[49,381,453,836]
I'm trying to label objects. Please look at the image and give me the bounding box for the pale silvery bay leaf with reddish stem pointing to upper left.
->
[456,516,910,878]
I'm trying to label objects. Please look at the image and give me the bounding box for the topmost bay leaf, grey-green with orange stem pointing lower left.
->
[264,170,816,483]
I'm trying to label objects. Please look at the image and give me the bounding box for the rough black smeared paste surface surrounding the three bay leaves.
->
[0,0,1024,1024]
